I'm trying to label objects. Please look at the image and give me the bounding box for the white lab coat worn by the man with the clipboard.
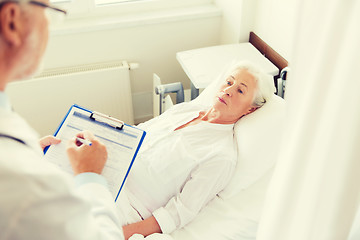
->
[0,107,123,240]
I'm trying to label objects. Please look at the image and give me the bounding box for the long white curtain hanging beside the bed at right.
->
[257,0,360,240]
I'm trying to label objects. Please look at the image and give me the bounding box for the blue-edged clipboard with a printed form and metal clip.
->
[44,104,146,201]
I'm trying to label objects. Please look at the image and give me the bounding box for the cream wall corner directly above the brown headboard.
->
[215,0,297,61]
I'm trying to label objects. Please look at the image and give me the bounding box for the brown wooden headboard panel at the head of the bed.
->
[249,32,289,72]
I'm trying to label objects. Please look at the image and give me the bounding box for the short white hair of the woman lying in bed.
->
[230,61,275,107]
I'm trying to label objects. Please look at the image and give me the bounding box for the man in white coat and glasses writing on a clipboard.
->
[0,0,123,240]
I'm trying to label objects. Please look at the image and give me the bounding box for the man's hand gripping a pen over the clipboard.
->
[67,131,107,175]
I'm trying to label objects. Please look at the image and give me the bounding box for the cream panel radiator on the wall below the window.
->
[6,61,134,136]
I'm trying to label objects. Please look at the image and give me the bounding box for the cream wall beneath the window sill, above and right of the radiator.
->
[44,9,221,122]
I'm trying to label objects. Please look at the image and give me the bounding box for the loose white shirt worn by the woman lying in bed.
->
[125,103,236,233]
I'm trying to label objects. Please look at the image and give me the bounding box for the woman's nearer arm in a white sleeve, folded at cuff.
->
[152,158,234,234]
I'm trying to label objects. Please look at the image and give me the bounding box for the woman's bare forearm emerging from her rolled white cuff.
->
[123,216,161,240]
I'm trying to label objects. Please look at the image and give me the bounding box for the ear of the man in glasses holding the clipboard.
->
[0,2,24,46]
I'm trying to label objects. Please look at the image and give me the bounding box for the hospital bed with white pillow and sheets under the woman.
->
[148,32,289,240]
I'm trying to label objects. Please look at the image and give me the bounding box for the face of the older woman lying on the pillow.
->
[213,69,256,123]
